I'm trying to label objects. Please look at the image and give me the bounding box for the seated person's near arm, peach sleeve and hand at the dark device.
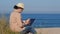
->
[16,14,30,28]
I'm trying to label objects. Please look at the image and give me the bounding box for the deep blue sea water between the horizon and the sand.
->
[0,14,60,28]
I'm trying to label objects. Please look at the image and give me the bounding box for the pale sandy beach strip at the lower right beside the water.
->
[35,28,60,34]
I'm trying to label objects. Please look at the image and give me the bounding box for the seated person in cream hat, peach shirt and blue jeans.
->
[10,3,35,34]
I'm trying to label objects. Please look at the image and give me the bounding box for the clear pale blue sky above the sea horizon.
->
[0,0,60,14]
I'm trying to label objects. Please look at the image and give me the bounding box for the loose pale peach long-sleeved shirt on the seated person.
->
[9,11,25,32]
